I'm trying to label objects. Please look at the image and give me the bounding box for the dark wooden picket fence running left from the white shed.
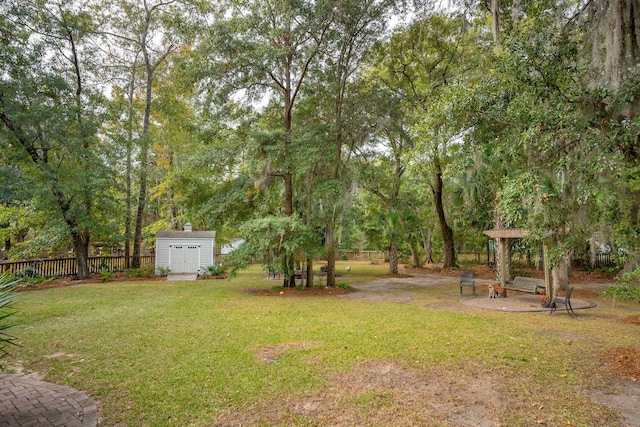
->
[0,255,156,277]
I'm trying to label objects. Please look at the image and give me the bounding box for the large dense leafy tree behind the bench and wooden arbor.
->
[469,2,638,289]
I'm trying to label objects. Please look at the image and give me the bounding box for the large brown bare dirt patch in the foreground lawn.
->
[215,361,503,427]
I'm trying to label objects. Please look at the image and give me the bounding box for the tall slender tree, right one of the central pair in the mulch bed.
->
[312,0,397,286]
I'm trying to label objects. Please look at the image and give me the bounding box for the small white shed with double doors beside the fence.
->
[156,223,216,274]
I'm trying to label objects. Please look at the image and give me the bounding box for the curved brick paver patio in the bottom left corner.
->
[0,373,98,427]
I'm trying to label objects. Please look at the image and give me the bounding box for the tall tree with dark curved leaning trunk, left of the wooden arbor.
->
[368,15,475,267]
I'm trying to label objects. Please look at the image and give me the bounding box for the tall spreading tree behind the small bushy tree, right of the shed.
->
[203,0,333,286]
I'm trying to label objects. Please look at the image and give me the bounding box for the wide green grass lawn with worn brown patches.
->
[4,262,640,426]
